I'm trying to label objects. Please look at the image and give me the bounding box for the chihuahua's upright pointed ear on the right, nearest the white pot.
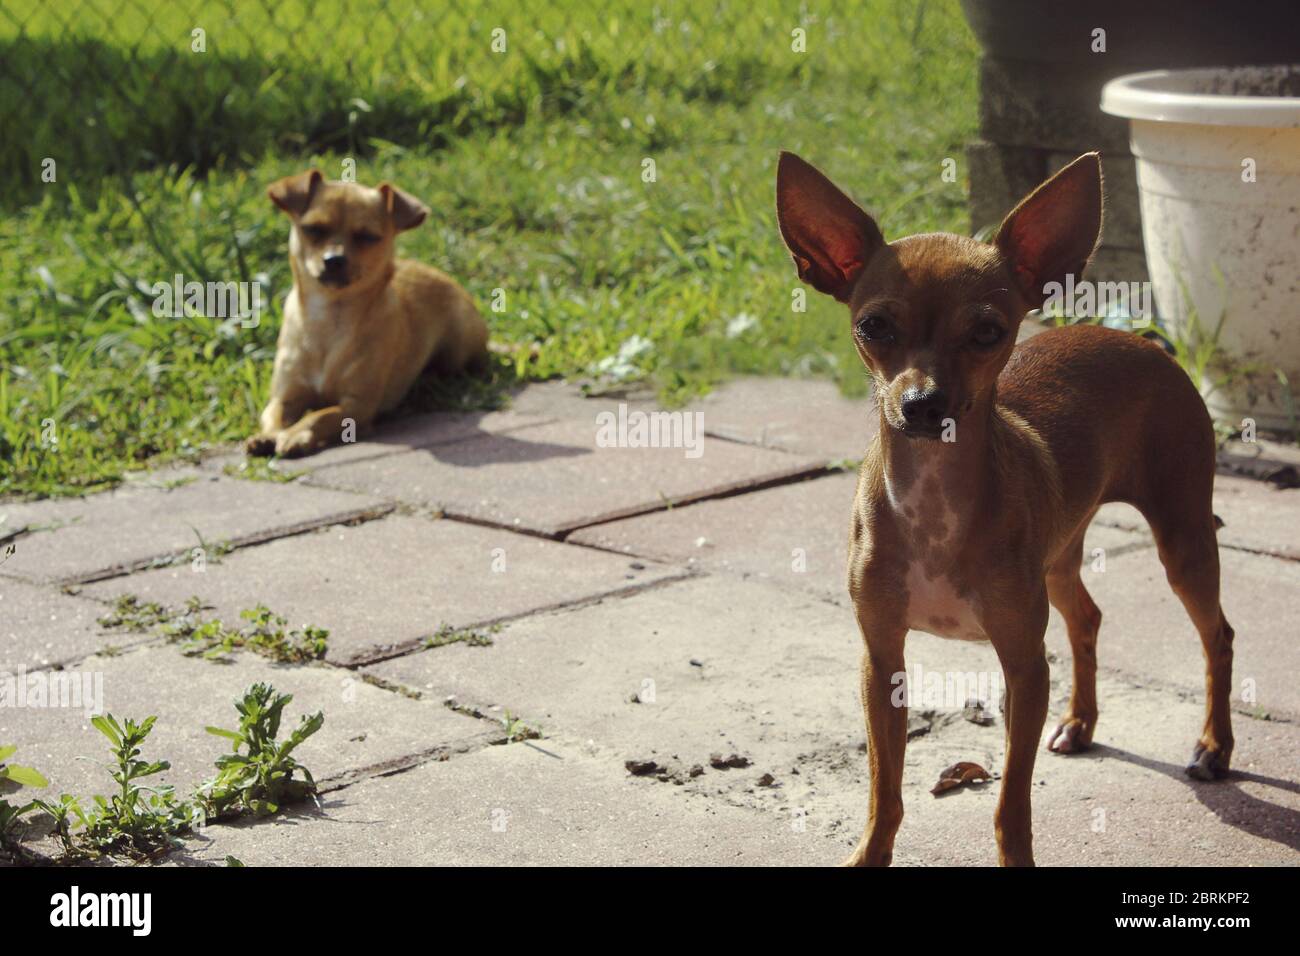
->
[993,152,1101,308]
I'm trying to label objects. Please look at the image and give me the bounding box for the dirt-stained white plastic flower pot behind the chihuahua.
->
[1101,66,1300,431]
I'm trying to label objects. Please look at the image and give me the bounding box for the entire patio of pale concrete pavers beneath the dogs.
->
[0,380,1300,865]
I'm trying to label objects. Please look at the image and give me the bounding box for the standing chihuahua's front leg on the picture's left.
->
[844,610,907,866]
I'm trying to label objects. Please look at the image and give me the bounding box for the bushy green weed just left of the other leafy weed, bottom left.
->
[69,714,194,858]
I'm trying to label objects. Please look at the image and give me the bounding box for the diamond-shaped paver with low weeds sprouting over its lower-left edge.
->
[85,515,681,663]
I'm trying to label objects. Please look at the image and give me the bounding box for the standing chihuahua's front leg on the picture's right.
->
[993,592,1049,866]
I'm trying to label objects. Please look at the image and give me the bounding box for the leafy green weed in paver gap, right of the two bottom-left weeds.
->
[198,683,325,819]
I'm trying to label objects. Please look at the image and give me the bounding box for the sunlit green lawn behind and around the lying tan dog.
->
[0,0,976,496]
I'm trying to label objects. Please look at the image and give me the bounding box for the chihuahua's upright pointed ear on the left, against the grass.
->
[776,151,884,302]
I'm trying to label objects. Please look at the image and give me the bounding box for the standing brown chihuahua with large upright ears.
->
[776,153,1232,865]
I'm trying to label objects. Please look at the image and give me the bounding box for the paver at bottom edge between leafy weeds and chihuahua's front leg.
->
[173,740,835,866]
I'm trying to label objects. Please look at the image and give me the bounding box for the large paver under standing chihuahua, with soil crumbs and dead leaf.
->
[361,579,1300,865]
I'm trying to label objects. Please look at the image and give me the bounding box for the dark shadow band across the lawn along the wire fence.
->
[0,34,780,208]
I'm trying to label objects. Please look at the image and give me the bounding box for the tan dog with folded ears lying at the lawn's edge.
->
[246,169,488,457]
